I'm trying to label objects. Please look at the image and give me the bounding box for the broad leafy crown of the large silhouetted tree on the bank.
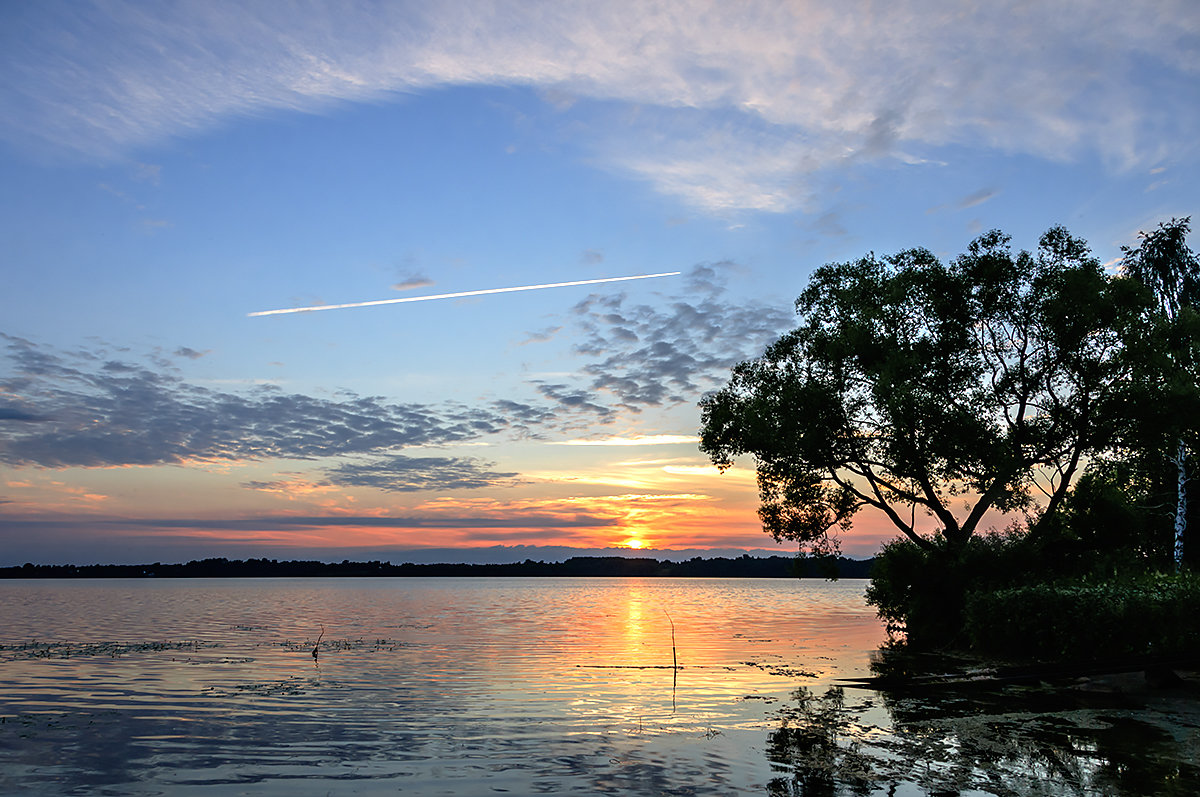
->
[701,227,1151,552]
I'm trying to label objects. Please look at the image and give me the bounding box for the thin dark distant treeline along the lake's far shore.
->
[0,556,874,579]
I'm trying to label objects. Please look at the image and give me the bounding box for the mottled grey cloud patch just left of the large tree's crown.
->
[564,262,793,412]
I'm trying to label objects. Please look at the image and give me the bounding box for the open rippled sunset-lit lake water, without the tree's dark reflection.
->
[0,579,882,795]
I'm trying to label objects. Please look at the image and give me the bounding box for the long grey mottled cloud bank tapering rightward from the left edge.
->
[0,334,552,468]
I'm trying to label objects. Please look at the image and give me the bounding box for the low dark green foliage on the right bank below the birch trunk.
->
[964,573,1200,658]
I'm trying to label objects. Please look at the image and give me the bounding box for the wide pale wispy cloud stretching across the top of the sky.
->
[0,0,1200,211]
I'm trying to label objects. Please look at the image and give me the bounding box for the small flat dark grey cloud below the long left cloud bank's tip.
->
[325,455,517,492]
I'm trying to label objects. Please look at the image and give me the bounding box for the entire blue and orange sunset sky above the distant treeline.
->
[0,0,1200,565]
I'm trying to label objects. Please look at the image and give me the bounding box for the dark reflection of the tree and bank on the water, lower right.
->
[767,652,1200,797]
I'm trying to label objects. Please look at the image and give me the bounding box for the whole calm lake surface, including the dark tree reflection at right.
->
[0,579,1200,797]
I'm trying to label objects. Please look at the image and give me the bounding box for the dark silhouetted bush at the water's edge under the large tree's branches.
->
[866,463,1176,652]
